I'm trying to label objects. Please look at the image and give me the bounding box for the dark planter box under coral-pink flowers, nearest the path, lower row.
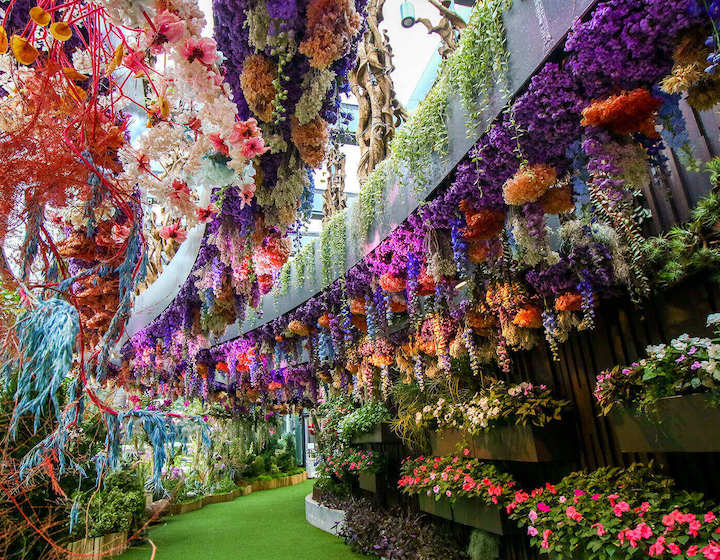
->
[418,494,518,535]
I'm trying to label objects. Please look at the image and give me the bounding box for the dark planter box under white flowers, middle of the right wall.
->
[432,422,572,463]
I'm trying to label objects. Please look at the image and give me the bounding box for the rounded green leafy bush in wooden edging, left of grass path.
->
[73,471,145,538]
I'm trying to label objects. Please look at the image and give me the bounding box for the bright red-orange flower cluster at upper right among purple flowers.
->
[581,88,662,138]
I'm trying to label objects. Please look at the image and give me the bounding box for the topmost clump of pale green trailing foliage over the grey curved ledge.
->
[442,0,512,122]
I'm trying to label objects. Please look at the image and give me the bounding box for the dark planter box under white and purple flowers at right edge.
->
[609,394,720,453]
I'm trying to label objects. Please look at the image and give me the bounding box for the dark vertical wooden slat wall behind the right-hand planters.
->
[513,100,720,499]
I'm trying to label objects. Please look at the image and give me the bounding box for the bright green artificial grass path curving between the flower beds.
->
[119,480,367,560]
